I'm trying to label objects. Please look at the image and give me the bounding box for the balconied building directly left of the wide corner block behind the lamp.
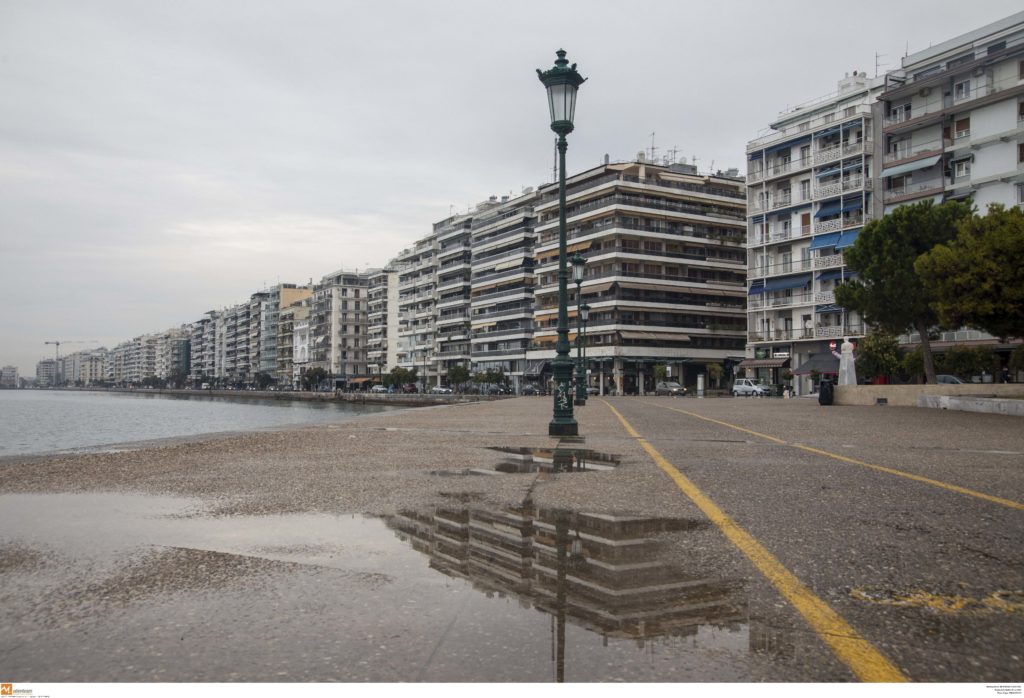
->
[470,189,539,392]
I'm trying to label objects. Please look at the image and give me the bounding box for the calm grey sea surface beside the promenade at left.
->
[0,390,394,459]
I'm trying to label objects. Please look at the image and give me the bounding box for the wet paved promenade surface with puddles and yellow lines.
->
[0,397,1024,684]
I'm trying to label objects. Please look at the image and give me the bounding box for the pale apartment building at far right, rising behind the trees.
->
[880,12,1024,351]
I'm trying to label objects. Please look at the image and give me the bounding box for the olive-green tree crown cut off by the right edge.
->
[914,204,1024,339]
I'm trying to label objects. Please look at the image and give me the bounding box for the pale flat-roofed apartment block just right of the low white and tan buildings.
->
[309,270,369,387]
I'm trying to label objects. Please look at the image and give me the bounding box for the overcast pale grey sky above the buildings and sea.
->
[0,0,1020,376]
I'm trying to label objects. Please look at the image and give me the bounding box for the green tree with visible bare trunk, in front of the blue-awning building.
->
[836,200,971,383]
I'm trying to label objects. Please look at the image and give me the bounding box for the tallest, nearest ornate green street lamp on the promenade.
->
[537,49,586,436]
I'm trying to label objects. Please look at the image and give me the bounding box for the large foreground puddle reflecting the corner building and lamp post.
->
[0,494,760,683]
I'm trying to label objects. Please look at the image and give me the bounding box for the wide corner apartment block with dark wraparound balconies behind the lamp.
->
[527,161,746,393]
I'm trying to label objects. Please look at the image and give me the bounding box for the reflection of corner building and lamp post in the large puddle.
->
[387,504,746,682]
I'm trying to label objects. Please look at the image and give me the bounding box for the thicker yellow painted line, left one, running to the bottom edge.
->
[601,400,908,683]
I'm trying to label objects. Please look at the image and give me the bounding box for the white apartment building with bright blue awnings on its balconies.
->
[740,73,884,393]
